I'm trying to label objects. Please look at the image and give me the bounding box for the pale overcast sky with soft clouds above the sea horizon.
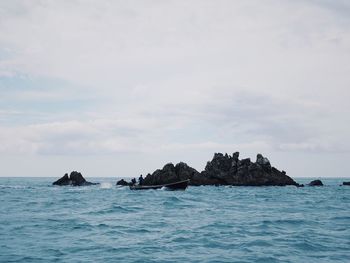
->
[0,0,350,177]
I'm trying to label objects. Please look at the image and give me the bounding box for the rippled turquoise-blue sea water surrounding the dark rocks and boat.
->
[0,178,350,263]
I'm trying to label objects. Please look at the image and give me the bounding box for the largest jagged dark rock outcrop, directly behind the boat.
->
[144,152,300,186]
